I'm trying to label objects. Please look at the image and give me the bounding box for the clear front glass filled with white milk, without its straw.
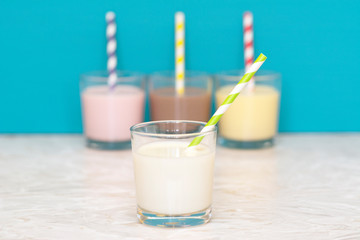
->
[131,120,217,228]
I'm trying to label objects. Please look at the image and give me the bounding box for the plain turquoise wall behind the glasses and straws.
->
[0,0,360,133]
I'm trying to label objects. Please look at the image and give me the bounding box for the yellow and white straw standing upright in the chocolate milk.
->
[175,12,185,95]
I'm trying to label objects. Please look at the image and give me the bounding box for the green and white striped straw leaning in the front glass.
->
[188,53,266,147]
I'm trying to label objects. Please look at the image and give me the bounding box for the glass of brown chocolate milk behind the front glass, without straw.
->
[149,71,212,122]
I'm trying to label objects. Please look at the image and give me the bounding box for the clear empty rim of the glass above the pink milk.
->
[80,70,145,83]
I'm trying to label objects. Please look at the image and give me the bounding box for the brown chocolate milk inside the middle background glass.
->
[150,87,211,122]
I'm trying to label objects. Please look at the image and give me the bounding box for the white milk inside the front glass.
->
[133,140,215,215]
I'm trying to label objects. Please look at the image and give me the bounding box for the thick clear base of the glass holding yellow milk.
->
[219,136,274,149]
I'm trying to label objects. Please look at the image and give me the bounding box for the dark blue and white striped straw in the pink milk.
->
[105,12,117,90]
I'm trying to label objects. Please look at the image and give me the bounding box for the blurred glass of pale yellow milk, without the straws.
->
[215,70,281,149]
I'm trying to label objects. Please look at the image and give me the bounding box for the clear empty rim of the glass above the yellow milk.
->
[214,69,281,82]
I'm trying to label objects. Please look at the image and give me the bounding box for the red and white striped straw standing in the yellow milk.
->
[243,12,255,91]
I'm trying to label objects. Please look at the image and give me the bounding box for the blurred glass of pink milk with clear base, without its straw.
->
[80,71,145,150]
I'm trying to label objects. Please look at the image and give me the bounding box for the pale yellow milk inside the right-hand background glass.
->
[216,86,280,141]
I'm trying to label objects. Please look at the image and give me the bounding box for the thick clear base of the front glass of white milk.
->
[137,207,211,228]
